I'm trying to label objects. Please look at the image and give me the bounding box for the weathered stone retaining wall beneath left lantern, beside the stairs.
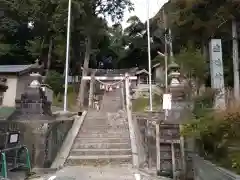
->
[0,120,73,168]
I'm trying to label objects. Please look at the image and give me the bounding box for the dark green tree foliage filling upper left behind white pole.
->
[0,0,132,68]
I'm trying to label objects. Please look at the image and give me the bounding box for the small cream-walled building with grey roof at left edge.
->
[0,64,41,107]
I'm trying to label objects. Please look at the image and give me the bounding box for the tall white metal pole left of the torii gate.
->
[64,0,72,111]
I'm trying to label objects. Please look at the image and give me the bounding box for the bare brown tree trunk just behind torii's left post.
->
[78,35,91,109]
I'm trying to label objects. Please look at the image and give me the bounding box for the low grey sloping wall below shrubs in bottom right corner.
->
[192,155,240,180]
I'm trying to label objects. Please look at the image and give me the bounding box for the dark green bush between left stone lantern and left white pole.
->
[45,71,64,95]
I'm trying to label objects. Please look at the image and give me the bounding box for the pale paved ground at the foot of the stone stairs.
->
[31,165,172,180]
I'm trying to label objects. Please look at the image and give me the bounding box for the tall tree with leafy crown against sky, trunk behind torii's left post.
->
[78,0,132,108]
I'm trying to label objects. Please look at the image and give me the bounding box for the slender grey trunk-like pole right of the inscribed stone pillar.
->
[232,19,240,101]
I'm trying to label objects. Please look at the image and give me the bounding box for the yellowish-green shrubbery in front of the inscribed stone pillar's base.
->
[183,88,240,173]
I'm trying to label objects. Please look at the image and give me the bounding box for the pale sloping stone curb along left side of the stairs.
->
[50,111,87,169]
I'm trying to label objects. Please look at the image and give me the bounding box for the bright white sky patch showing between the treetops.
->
[122,0,168,28]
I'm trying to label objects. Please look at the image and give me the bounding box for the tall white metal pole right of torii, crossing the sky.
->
[146,0,153,111]
